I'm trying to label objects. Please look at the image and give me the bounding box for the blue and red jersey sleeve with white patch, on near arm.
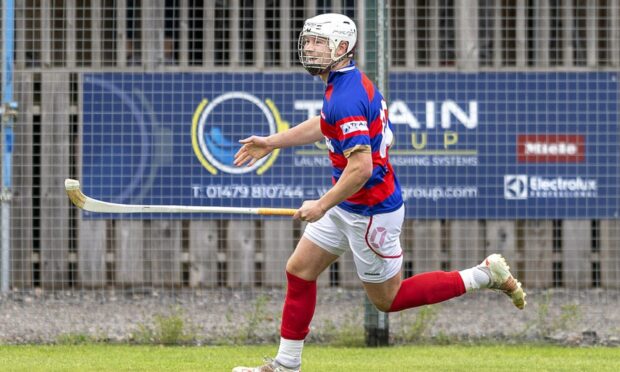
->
[334,100,371,158]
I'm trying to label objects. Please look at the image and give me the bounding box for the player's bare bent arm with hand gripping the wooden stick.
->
[293,150,372,222]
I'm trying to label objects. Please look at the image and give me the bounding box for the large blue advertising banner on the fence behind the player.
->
[82,72,620,219]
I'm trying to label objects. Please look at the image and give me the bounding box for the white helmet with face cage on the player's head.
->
[297,13,357,75]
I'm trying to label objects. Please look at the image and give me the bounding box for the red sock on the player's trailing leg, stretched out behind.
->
[390,271,465,312]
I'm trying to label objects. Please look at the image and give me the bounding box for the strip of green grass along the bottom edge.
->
[0,344,620,372]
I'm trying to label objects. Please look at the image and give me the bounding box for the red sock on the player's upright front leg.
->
[280,271,316,340]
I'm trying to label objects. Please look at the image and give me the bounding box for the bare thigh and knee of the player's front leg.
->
[286,236,338,281]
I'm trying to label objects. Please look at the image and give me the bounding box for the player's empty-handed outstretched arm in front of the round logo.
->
[235,116,323,167]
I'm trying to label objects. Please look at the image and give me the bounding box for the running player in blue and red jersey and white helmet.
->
[233,14,525,372]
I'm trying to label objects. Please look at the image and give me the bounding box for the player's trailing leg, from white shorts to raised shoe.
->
[347,205,525,311]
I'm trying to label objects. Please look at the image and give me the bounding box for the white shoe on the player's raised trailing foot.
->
[477,253,527,310]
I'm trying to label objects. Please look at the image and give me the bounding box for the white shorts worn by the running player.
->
[304,205,405,283]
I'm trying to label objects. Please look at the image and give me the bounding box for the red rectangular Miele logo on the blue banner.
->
[517,134,585,163]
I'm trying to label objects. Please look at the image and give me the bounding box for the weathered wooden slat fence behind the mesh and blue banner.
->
[2,0,620,289]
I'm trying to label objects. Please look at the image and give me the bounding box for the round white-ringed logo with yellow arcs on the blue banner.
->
[192,92,289,175]
